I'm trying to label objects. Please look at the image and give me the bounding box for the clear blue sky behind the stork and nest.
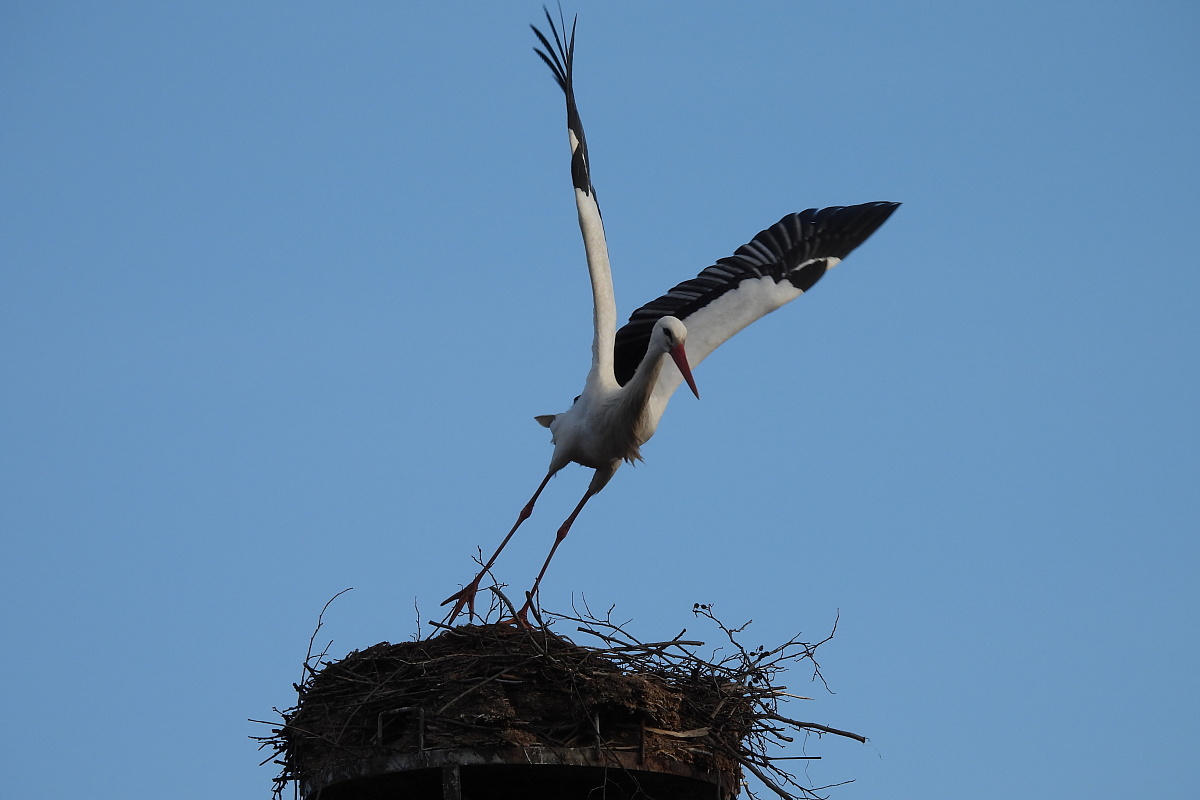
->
[0,1,1200,800]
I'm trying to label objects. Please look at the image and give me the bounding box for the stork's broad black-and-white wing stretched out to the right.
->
[614,203,900,403]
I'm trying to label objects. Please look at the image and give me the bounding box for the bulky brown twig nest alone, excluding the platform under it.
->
[256,604,865,800]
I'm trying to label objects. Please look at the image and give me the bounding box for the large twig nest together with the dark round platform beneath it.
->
[257,604,865,800]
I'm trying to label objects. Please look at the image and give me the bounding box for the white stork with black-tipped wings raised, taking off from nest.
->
[442,11,899,626]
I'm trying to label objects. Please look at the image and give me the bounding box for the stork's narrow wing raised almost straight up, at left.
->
[530,11,617,383]
